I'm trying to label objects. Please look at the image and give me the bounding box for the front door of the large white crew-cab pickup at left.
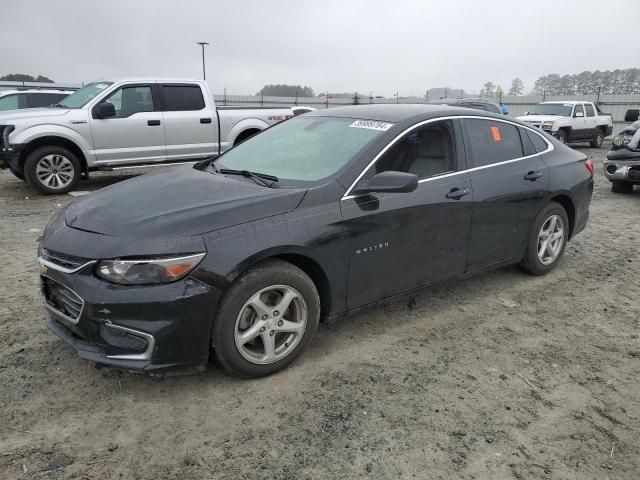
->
[91,85,166,164]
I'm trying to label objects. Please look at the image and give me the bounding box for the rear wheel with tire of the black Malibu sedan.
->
[520,202,569,275]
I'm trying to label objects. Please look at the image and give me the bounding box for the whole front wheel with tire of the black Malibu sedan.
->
[211,260,320,378]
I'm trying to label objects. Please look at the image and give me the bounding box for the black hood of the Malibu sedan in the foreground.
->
[65,166,306,238]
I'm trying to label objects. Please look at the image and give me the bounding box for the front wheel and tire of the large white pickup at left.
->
[24,146,82,195]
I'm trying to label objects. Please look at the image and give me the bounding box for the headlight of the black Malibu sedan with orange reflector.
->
[96,253,205,285]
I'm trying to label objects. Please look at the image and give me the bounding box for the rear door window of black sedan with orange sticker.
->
[462,118,523,167]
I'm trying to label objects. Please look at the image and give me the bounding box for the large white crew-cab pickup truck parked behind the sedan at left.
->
[0,79,293,194]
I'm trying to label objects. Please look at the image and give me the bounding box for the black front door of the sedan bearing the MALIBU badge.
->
[341,121,473,309]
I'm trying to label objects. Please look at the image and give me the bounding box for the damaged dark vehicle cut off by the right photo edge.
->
[604,109,640,193]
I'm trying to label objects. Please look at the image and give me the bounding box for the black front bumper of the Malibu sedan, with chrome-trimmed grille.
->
[40,261,220,371]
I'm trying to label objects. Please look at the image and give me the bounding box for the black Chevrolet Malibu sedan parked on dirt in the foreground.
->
[39,105,593,377]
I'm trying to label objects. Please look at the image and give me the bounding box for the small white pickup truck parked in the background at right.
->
[517,101,613,148]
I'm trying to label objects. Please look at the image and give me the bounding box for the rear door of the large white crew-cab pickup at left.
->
[161,83,218,160]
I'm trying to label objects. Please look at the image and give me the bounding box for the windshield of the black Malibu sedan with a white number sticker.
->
[215,117,393,182]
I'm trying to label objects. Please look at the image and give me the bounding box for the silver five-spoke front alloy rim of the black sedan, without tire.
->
[234,285,308,365]
